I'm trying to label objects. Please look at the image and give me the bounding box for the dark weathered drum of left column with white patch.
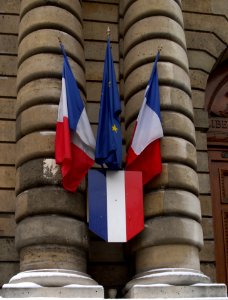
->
[16,158,85,194]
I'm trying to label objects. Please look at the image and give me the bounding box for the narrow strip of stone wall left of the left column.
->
[0,0,20,286]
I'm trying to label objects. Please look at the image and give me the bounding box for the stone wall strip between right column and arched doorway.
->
[182,0,228,281]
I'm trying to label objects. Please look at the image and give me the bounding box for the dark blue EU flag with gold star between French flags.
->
[95,38,122,170]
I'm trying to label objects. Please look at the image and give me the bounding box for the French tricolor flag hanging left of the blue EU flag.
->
[55,45,96,192]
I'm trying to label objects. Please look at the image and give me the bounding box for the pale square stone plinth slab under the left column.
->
[0,285,104,299]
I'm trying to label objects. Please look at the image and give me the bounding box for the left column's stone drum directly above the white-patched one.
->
[16,131,55,167]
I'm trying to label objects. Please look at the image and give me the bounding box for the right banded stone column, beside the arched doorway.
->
[123,0,227,298]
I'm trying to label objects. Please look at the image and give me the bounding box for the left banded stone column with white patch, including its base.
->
[1,0,103,297]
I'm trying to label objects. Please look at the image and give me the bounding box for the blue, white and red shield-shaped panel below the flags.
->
[88,169,144,242]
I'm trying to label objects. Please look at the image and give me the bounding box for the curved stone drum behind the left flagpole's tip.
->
[18,29,85,67]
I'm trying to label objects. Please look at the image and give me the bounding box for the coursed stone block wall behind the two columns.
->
[0,0,228,288]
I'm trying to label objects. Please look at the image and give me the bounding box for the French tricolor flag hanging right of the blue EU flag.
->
[126,52,163,184]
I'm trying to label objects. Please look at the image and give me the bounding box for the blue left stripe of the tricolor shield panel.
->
[88,170,108,241]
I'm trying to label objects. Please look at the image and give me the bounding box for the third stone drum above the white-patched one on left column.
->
[16,78,61,114]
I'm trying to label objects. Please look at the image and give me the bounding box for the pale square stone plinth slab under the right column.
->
[125,284,228,300]
